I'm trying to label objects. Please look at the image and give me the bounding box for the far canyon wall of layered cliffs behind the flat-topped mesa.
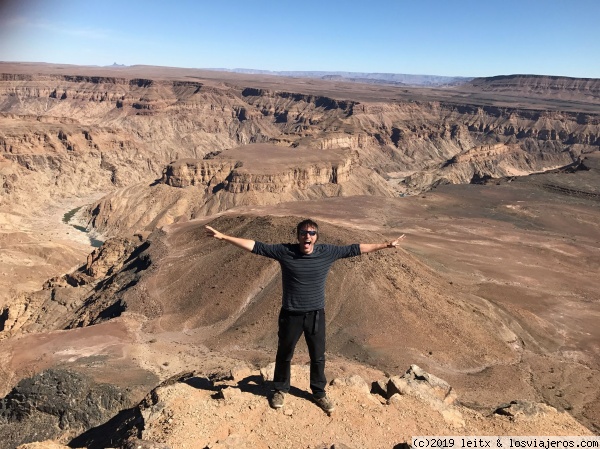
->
[0,74,600,215]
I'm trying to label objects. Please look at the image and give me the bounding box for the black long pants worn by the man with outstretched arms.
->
[273,309,327,398]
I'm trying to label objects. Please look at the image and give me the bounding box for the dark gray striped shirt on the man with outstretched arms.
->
[252,242,360,312]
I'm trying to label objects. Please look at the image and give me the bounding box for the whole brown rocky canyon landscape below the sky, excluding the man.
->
[0,63,600,448]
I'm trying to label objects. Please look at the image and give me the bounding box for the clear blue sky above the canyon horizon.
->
[0,0,600,78]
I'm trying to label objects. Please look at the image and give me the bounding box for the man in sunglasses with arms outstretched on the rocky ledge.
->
[206,220,404,413]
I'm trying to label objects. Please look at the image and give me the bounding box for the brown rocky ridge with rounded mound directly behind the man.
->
[3,212,517,368]
